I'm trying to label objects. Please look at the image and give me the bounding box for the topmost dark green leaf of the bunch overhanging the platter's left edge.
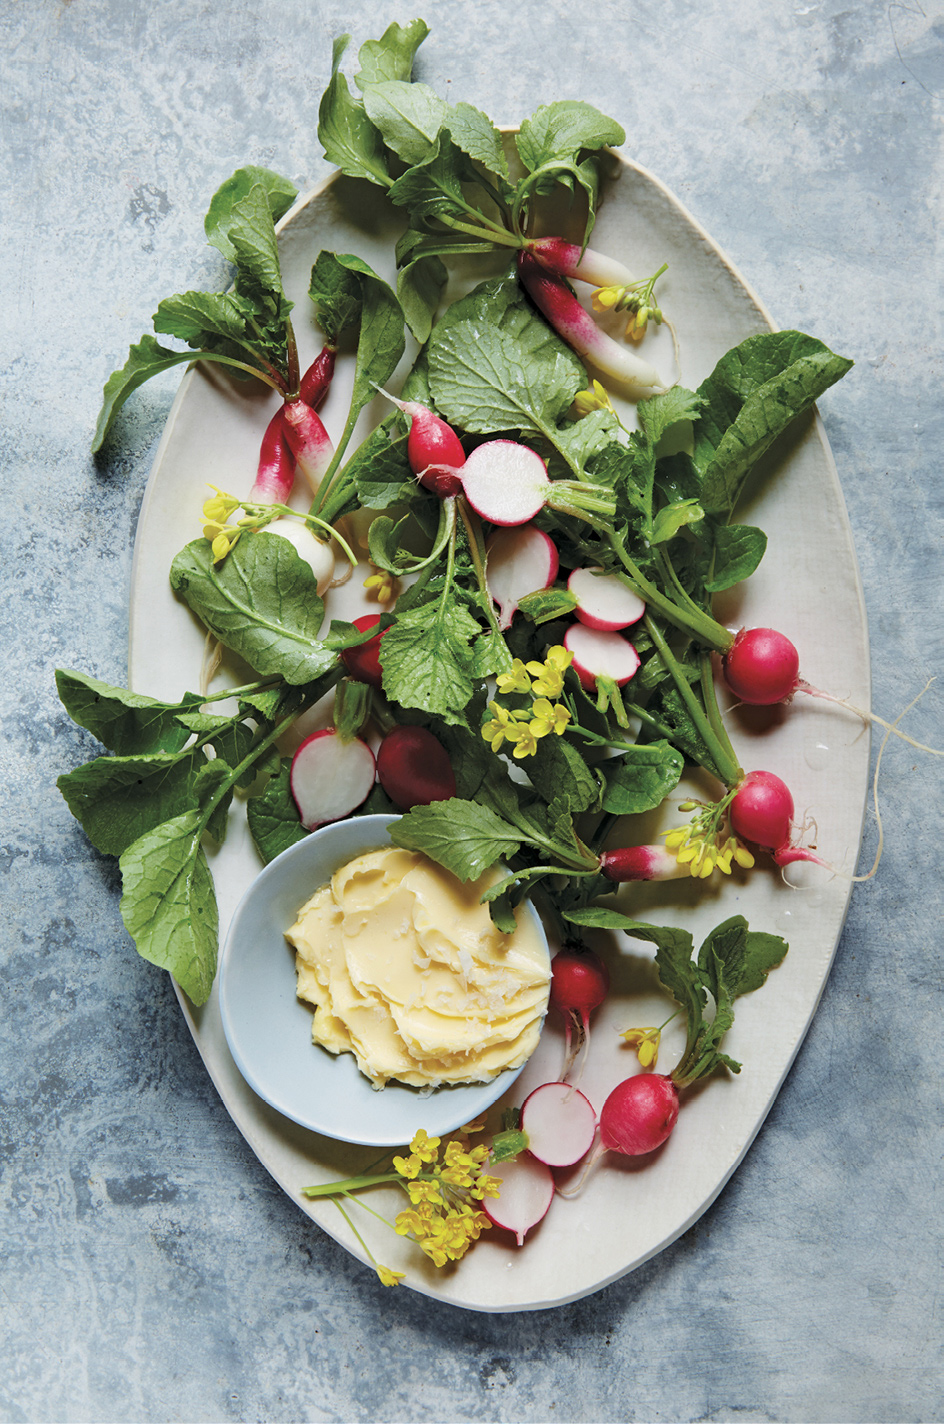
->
[56,668,201,756]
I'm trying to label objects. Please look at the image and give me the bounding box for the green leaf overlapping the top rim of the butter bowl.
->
[390,797,522,880]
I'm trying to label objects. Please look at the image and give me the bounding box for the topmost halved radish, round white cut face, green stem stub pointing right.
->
[460,440,615,528]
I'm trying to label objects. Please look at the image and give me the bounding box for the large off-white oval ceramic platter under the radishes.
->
[130,150,870,1312]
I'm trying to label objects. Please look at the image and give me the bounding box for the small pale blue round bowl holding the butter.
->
[219,816,545,1148]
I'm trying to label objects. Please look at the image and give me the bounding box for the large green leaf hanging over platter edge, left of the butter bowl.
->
[120,810,219,1005]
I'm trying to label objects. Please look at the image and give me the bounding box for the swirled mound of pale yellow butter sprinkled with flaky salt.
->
[286,847,551,1088]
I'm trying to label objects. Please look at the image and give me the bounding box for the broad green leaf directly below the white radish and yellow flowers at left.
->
[171,531,336,686]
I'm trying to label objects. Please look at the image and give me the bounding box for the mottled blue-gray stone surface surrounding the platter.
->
[0,0,942,1424]
